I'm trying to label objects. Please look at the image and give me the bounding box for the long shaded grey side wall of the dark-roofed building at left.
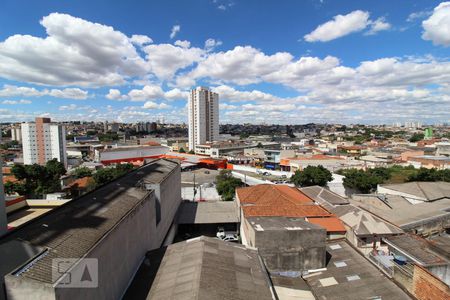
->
[55,192,156,300]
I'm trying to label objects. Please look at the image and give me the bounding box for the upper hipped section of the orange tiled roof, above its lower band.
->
[236,184,313,206]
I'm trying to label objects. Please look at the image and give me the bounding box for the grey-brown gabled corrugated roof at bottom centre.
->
[147,236,272,300]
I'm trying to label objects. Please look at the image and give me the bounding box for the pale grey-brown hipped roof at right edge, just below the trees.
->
[380,181,450,201]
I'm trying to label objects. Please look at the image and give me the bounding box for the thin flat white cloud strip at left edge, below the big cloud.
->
[0,84,88,100]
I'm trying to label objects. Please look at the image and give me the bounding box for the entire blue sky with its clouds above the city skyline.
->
[0,0,450,124]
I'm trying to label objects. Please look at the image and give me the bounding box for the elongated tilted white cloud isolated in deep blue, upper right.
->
[304,10,369,42]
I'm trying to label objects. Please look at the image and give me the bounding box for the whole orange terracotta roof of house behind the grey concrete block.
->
[236,184,346,240]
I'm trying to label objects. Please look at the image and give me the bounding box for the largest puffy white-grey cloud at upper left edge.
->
[0,13,147,87]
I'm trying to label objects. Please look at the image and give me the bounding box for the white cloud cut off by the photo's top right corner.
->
[422,2,450,46]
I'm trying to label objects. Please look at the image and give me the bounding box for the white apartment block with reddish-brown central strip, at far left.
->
[22,118,67,166]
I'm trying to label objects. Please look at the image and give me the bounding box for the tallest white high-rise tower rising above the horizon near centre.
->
[188,87,219,150]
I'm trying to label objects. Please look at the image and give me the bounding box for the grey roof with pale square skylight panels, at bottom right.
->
[303,241,412,300]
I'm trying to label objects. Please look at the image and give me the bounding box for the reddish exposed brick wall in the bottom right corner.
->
[413,265,450,300]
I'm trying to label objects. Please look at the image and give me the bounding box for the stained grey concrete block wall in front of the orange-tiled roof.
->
[249,228,326,272]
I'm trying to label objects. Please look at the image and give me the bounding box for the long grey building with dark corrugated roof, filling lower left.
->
[0,159,181,299]
